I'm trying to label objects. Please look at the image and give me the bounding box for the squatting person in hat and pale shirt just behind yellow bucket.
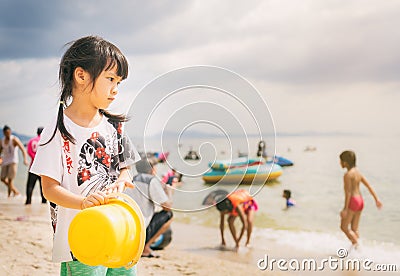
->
[124,158,172,258]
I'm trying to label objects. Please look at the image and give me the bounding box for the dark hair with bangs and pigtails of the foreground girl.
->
[42,36,128,145]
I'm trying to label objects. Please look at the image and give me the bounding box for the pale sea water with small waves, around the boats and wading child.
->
[0,135,400,263]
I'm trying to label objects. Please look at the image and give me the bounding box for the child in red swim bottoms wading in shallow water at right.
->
[340,151,382,248]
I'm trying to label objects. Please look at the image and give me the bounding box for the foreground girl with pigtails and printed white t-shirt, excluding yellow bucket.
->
[31,36,140,275]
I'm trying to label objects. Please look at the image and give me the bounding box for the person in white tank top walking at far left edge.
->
[0,125,28,197]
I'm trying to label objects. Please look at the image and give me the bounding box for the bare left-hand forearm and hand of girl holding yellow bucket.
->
[41,175,108,210]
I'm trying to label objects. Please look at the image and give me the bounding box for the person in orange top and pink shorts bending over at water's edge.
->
[216,190,258,251]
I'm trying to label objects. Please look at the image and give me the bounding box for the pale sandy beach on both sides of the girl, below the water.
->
[0,197,400,275]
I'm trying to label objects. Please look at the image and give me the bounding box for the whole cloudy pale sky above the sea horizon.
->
[0,0,400,141]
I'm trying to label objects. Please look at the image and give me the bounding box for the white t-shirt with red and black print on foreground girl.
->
[30,115,140,262]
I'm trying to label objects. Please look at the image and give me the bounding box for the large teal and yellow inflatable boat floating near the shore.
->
[203,158,283,184]
